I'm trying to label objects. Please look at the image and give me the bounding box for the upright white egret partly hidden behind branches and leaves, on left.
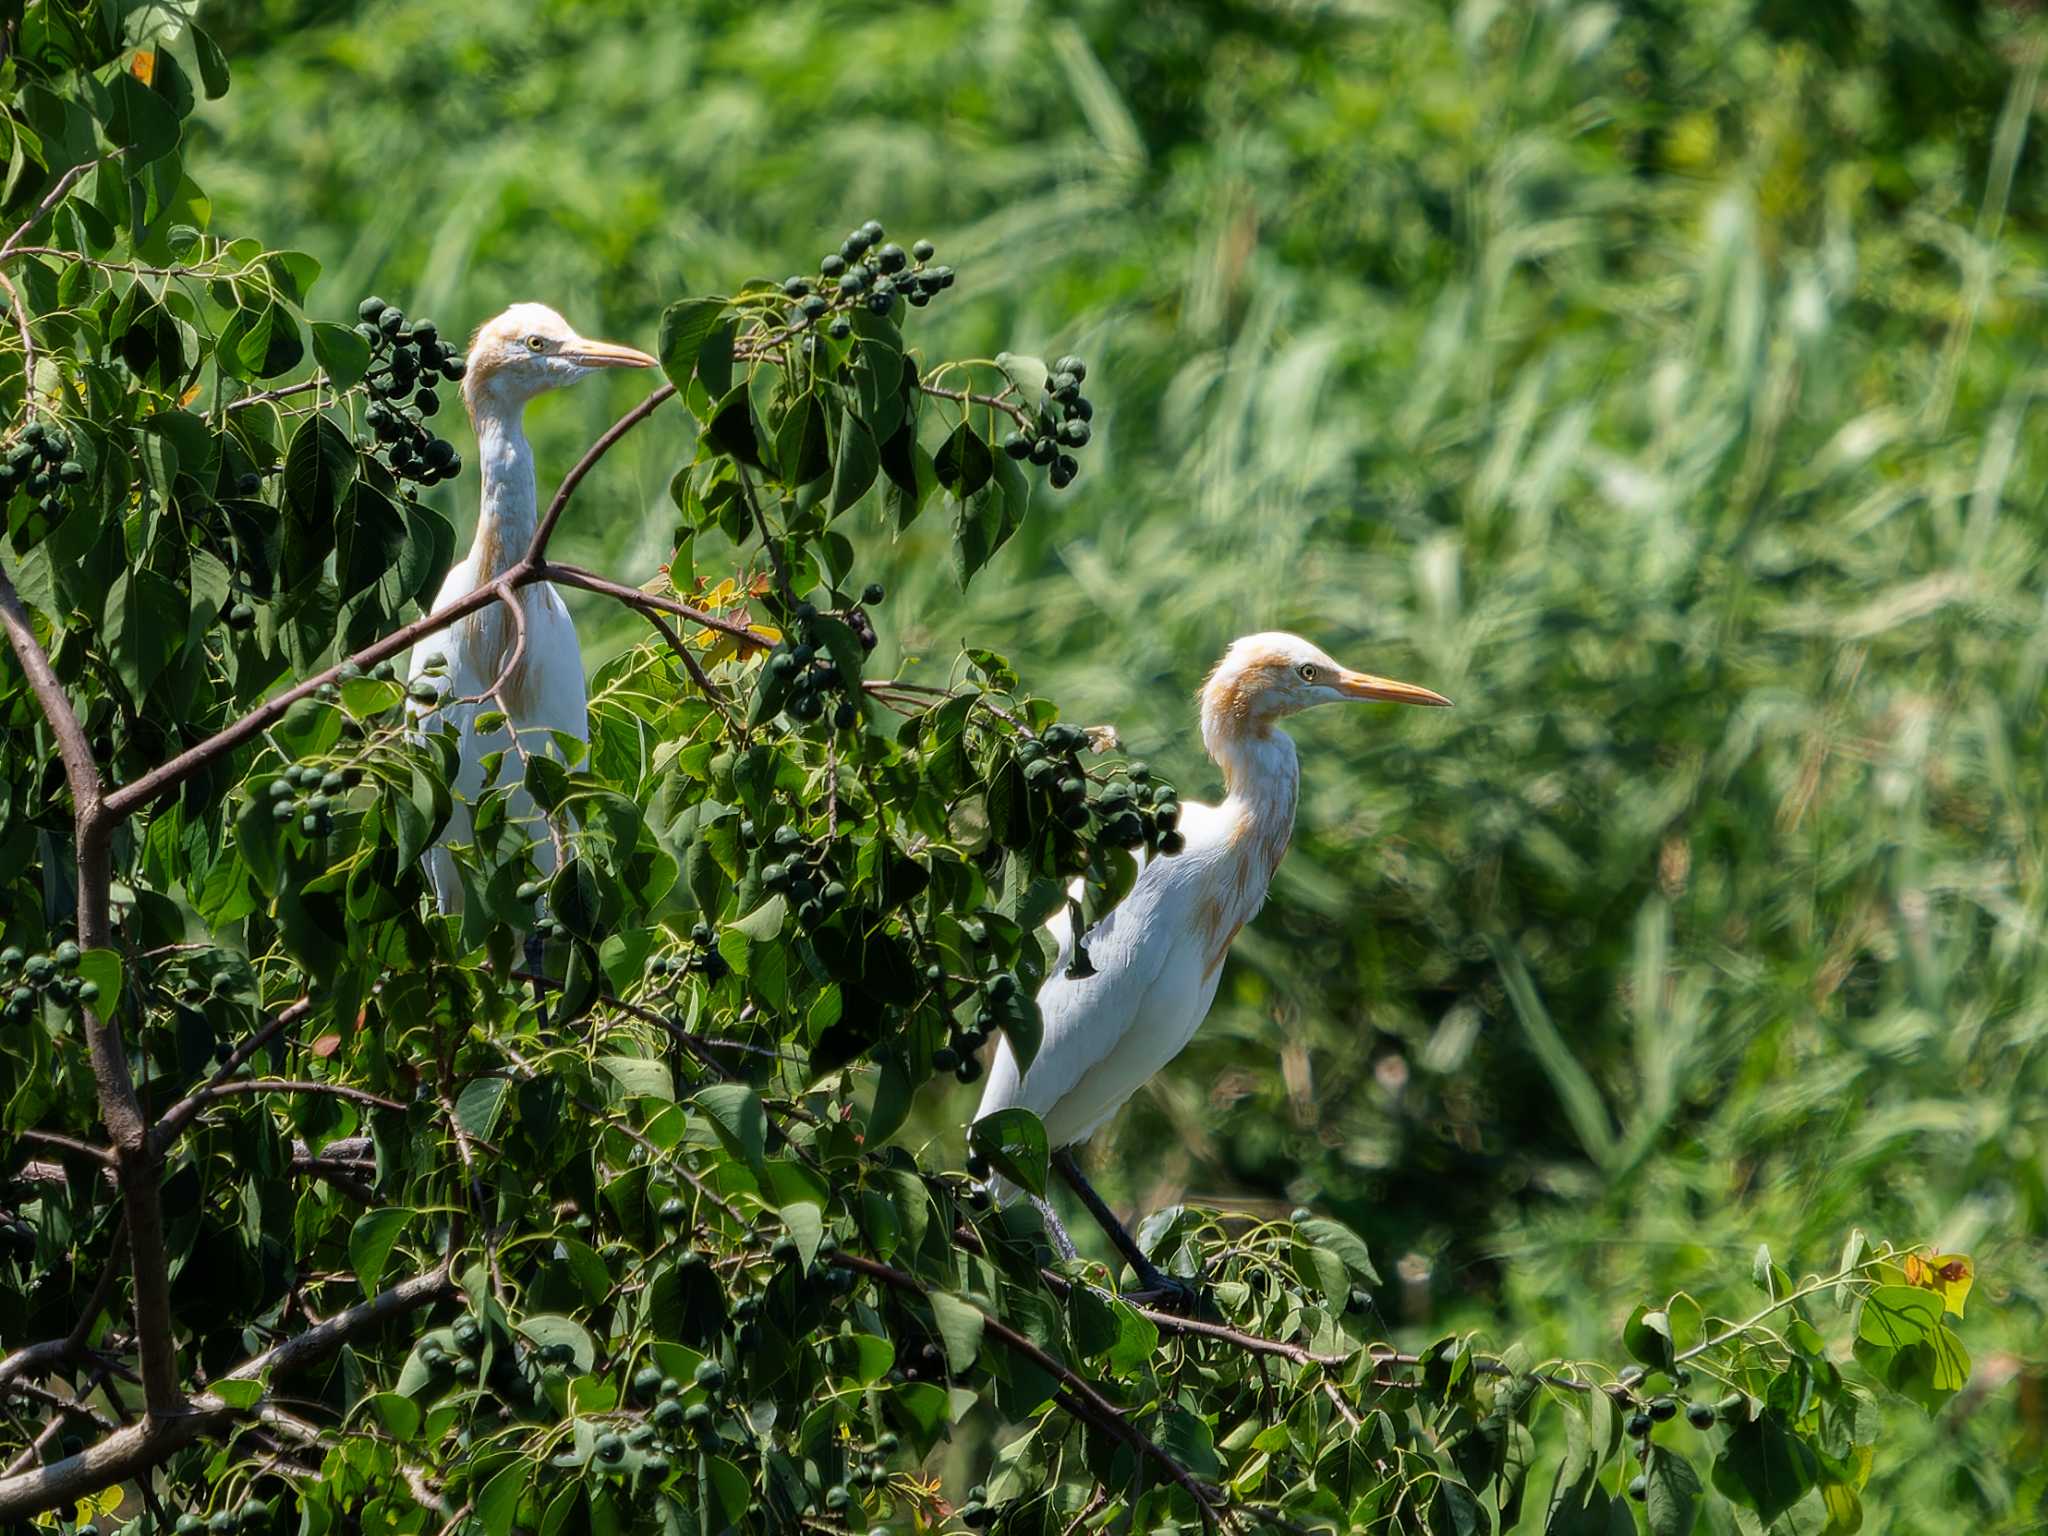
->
[412,303,655,911]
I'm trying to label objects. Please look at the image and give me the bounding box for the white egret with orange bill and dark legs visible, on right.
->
[975,633,1450,1294]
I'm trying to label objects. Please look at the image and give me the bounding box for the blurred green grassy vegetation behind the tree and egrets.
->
[188,0,2048,1532]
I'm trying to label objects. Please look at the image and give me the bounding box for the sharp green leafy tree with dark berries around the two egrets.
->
[0,0,2015,1536]
